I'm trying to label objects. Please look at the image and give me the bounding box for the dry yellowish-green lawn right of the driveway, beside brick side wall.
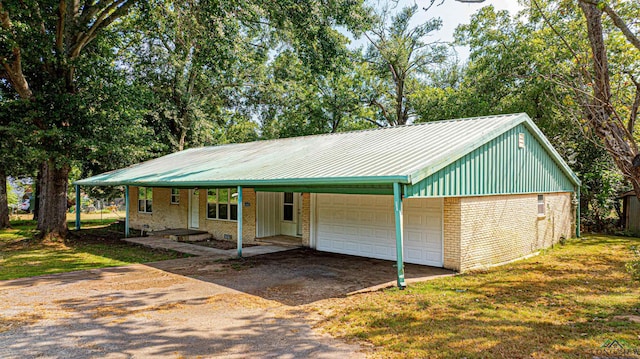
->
[321,235,640,359]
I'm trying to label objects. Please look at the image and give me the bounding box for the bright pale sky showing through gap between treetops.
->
[352,0,522,62]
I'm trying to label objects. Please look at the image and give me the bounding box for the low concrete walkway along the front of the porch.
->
[123,236,296,258]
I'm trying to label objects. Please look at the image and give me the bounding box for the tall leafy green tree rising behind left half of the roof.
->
[131,0,370,151]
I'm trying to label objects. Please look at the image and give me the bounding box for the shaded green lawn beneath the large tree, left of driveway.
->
[0,219,184,280]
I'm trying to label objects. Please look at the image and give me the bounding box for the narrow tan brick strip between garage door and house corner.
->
[443,197,461,271]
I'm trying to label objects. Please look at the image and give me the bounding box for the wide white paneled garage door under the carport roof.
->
[316,194,442,267]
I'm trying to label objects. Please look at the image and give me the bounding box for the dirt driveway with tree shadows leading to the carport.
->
[0,249,448,358]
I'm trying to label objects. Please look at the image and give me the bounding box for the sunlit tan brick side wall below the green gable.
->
[456,193,573,271]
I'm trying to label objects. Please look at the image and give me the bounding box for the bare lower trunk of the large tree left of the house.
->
[38,159,70,239]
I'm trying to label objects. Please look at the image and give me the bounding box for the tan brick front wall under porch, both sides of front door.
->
[129,187,256,242]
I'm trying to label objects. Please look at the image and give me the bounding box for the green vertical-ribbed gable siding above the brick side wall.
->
[405,124,574,197]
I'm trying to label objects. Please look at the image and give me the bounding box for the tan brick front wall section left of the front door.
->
[129,187,189,231]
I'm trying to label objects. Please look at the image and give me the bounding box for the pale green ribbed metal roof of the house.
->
[75,113,580,188]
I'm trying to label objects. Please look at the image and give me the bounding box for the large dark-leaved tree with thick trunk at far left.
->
[0,0,136,237]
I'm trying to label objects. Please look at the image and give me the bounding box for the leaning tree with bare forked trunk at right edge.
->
[576,0,640,199]
